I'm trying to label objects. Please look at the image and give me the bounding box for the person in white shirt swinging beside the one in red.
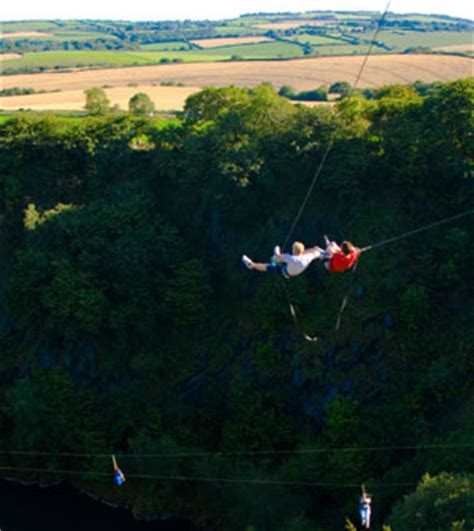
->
[242,242,322,278]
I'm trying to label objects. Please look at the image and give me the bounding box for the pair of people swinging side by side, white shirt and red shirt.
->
[242,236,361,278]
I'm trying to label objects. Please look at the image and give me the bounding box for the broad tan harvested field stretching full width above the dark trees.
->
[2,54,473,98]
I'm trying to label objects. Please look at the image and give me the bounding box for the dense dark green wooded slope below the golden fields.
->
[0,79,474,531]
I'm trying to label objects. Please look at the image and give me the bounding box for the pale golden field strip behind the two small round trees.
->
[0,85,200,111]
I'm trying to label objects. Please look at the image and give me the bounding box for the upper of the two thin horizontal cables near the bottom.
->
[0,441,474,459]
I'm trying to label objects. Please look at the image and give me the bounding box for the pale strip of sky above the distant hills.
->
[0,0,474,20]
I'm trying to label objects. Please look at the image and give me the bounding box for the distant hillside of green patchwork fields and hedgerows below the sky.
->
[0,11,472,74]
